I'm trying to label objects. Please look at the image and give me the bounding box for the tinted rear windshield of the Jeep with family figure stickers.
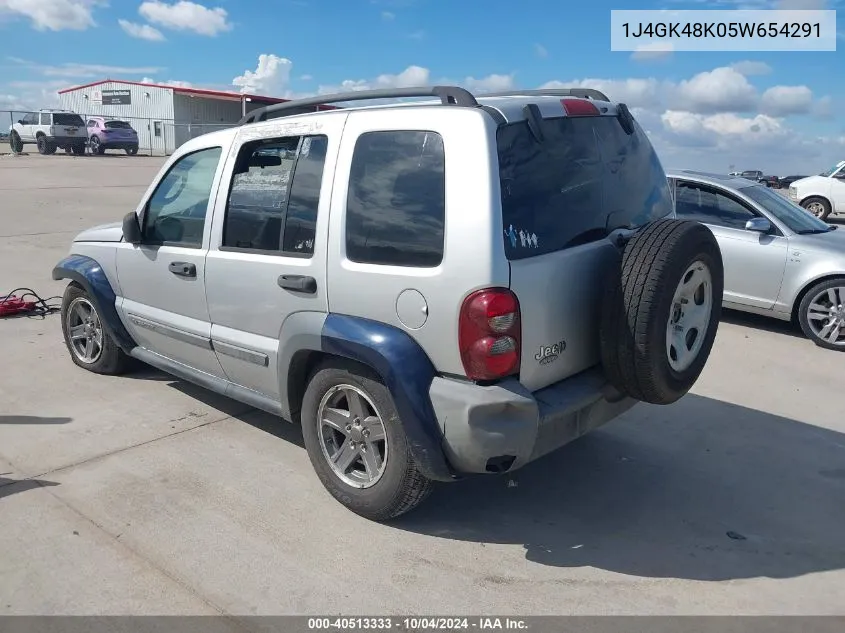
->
[497,116,672,260]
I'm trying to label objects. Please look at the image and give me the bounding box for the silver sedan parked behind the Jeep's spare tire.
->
[667,170,845,351]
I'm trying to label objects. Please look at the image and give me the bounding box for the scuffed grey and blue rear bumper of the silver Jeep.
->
[429,369,637,473]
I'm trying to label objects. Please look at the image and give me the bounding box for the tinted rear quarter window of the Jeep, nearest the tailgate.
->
[346,131,446,268]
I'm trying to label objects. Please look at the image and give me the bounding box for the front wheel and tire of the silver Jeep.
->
[61,283,129,376]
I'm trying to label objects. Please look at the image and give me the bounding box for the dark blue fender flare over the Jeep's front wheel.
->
[53,255,136,354]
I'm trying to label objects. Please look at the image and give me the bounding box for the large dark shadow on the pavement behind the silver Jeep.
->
[392,395,845,582]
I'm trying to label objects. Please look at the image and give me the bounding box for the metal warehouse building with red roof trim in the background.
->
[59,79,326,155]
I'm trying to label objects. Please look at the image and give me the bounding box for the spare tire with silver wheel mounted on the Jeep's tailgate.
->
[600,219,724,404]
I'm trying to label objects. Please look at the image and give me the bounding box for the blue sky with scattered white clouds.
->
[0,0,845,176]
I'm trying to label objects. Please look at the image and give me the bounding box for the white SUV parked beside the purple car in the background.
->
[9,110,88,156]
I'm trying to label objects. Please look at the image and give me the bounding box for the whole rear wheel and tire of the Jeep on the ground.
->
[302,361,432,521]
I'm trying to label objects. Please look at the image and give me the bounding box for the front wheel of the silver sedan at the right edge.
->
[798,279,845,352]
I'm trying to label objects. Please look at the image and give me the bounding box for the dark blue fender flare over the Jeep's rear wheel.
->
[320,314,456,481]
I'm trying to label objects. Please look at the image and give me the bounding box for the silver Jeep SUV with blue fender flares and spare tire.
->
[53,86,723,520]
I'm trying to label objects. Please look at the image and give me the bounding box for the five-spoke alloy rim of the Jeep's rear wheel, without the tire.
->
[317,385,388,488]
